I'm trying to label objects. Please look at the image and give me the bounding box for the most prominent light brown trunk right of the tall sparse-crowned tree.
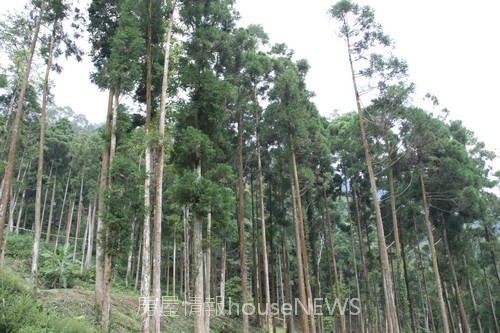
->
[420,162,450,333]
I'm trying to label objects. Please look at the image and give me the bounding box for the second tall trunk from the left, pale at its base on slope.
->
[31,20,58,274]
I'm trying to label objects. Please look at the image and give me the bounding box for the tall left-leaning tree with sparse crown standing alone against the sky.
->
[330,0,406,333]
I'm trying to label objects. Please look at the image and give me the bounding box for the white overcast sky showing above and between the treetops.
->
[0,0,500,174]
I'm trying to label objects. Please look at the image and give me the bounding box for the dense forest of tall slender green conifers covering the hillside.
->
[0,0,500,333]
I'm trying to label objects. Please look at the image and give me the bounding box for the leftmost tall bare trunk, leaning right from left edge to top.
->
[0,0,45,244]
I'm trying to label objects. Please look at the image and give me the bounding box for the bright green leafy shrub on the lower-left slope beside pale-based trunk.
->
[39,243,80,288]
